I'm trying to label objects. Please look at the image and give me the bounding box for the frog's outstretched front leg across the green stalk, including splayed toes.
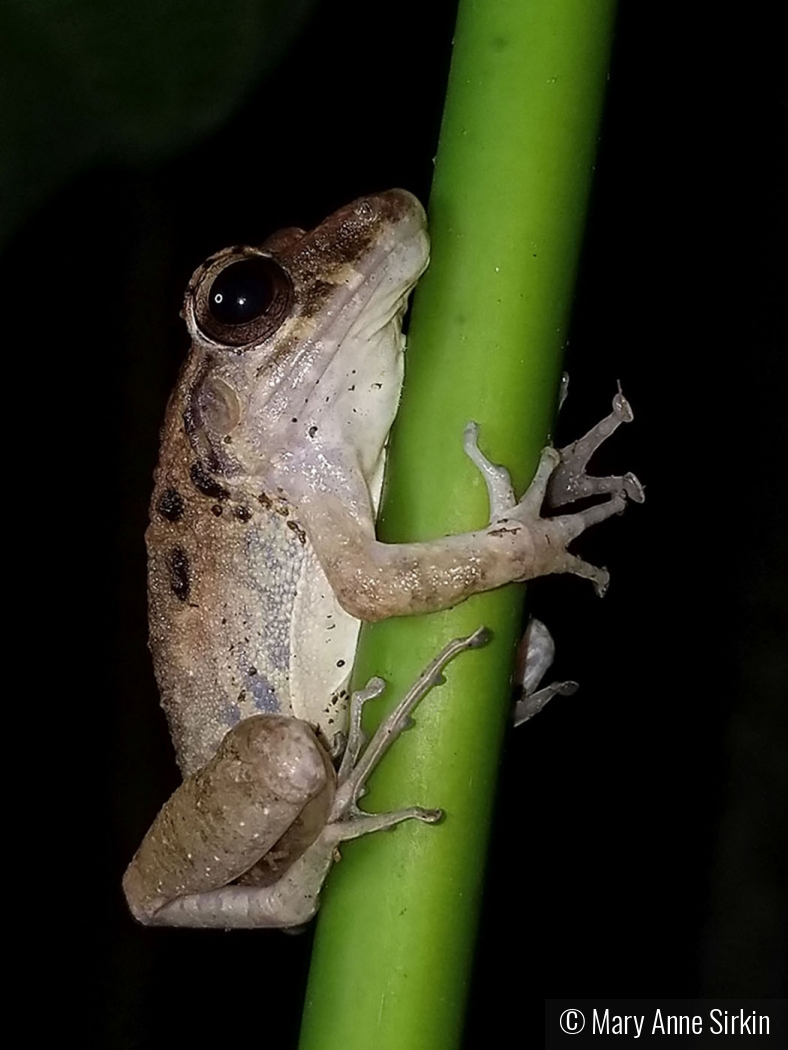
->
[294,394,643,621]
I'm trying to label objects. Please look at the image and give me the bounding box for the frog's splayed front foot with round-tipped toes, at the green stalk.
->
[463,391,644,595]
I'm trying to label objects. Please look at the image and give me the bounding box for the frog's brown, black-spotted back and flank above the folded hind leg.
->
[145,382,305,775]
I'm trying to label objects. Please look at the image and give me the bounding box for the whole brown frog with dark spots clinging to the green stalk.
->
[123,189,643,928]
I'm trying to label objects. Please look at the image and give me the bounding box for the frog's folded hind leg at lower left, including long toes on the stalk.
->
[124,629,486,928]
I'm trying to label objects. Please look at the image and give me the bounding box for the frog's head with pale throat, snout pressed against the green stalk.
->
[184,190,429,475]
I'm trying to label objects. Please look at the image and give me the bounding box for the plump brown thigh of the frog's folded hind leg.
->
[123,715,334,923]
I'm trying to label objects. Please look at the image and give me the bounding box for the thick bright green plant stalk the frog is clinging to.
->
[300,0,615,1050]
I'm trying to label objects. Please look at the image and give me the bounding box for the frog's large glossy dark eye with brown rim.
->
[194,249,292,347]
